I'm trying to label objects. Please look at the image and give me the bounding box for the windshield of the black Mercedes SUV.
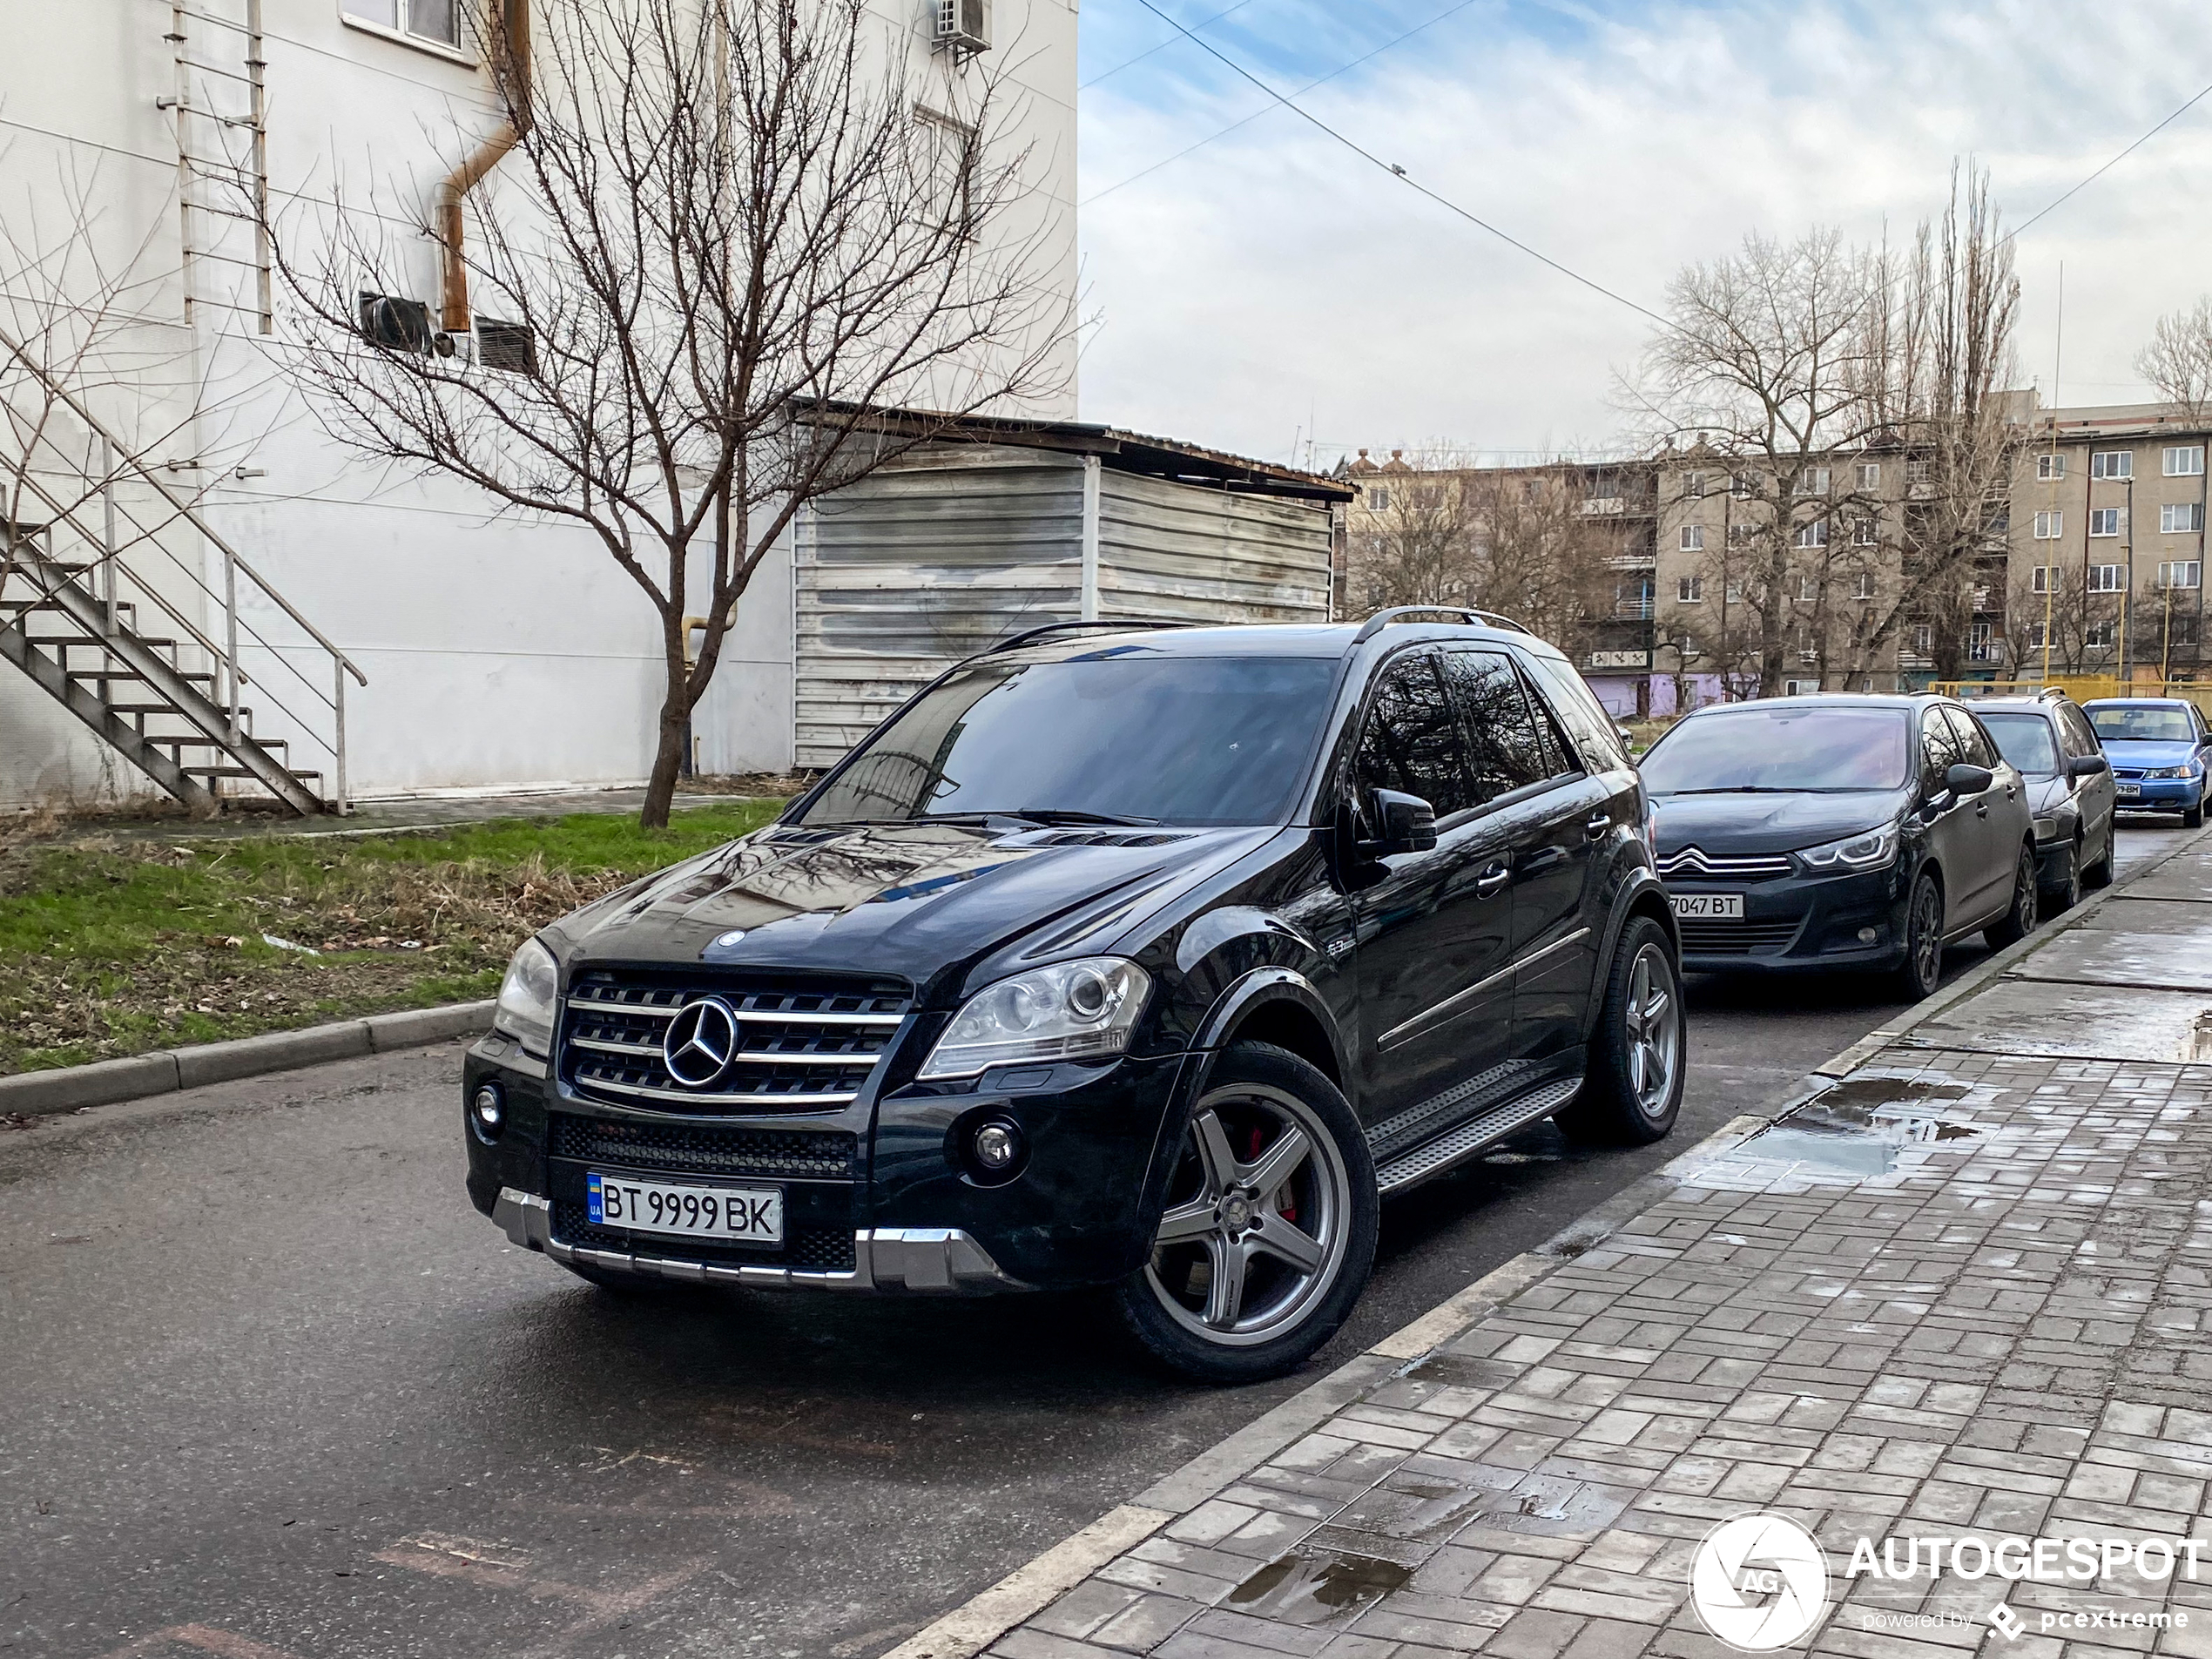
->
[800,655,1336,825]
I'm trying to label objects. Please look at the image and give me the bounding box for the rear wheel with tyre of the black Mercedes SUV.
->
[1553,916,1690,1146]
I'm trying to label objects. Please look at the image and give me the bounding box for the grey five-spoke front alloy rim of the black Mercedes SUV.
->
[1143,1084,1352,1347]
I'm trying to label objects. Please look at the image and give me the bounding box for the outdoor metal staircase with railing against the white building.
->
[0,329,369,814]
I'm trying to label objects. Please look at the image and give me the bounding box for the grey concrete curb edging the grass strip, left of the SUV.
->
[0,1002,491,1117]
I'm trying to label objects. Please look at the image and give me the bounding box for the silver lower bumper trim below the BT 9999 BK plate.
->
[491,1185,1031,1291]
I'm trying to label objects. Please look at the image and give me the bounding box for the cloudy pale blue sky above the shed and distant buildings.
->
[1080,0,2212,464]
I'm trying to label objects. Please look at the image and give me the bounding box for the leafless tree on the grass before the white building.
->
[274,0,1073,825]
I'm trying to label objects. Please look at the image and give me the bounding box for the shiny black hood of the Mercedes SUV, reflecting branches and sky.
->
[549,820,1278,1007]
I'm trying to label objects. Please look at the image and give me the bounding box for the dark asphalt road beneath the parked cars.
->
[0,820,2176,1659]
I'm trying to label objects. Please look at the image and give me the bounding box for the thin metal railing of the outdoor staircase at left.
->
[0,327,369,814]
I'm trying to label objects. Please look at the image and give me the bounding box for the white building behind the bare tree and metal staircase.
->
[0,0,1075,807]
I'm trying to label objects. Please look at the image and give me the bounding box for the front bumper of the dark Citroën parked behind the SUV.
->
[1666,859,1909,974]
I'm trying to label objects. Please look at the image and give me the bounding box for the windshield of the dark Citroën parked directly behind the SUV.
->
[1642,701,1912,794]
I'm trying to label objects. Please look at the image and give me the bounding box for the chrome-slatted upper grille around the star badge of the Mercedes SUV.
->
[562,969,914,1113]
